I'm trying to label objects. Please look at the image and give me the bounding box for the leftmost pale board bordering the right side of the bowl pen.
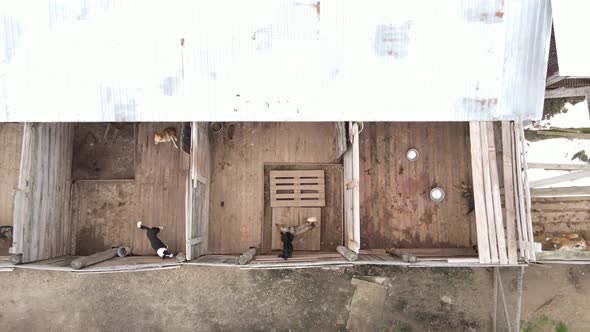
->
[469,122,491,263]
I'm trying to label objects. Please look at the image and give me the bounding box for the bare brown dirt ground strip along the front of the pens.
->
[0,265,590,331]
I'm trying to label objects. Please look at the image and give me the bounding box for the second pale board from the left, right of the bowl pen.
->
[480,122,500,263]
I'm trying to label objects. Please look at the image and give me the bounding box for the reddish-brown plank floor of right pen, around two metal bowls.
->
[360,123,475,248]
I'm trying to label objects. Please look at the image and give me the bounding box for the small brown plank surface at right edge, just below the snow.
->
[531,196,590,235]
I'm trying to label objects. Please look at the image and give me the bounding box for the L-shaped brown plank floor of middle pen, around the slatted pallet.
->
[209,123,337,254]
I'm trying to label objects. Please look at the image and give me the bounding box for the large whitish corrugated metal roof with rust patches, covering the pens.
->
[0,0,551,121]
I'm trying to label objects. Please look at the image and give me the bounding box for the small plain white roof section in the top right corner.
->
[553,0,590,77]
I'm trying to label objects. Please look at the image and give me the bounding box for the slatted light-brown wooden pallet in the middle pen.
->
[270,170,326,207]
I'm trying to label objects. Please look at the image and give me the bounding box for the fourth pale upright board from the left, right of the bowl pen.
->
[502,121,518,264]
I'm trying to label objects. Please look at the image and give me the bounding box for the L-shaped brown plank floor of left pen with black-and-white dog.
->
[72,123,189,255]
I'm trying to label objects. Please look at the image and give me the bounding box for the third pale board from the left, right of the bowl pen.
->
[486,122,508,264]
